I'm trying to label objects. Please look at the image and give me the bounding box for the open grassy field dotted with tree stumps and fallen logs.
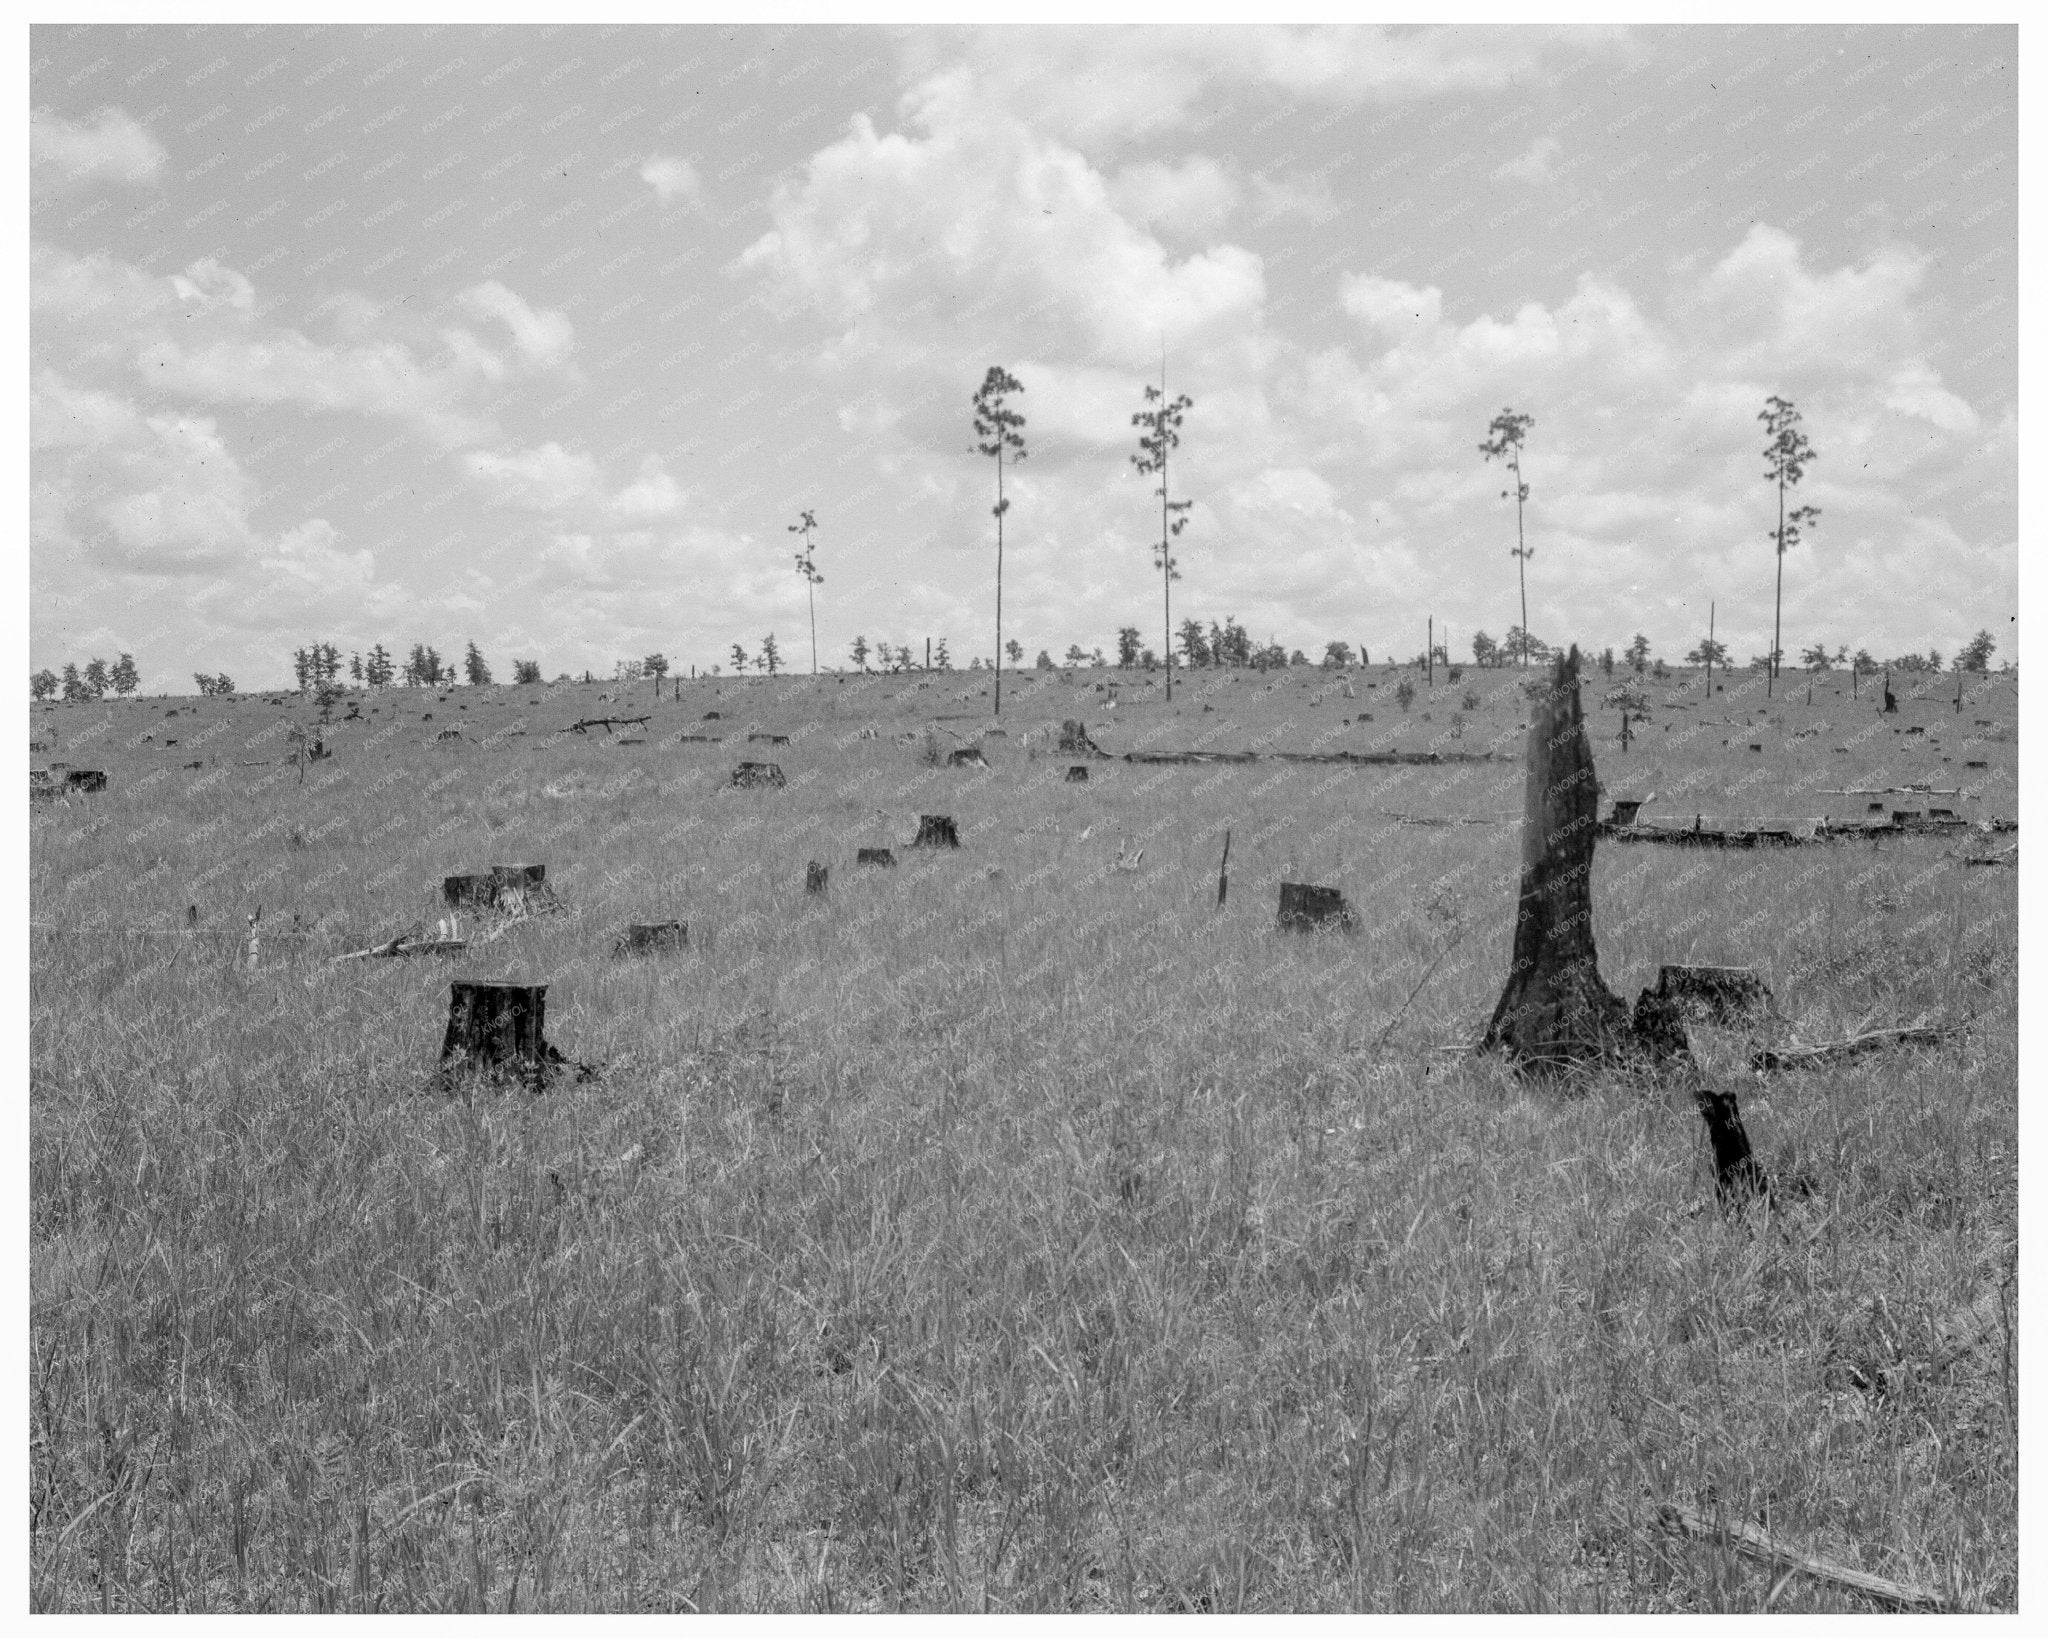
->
[29,667,2019,1609]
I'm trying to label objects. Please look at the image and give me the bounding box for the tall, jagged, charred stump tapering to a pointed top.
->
[1481,645,1634,1071]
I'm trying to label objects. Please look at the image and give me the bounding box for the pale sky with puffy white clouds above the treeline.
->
[29,25,2017,692]
